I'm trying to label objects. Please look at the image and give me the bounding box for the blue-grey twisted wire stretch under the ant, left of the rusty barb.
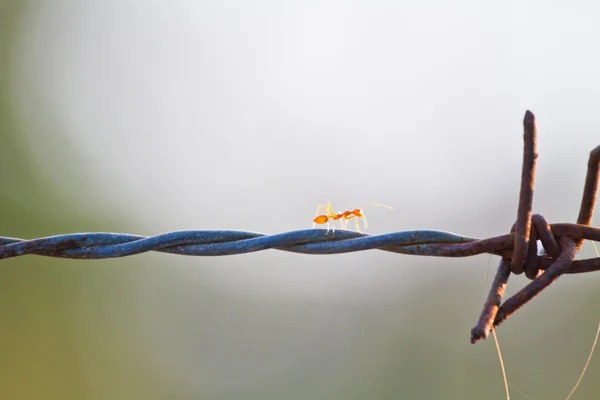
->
[0,229,478,259]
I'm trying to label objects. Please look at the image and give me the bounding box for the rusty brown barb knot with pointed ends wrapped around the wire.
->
[471,110,600,343]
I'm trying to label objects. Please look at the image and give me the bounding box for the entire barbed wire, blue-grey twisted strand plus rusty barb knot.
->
[0,111,600,343]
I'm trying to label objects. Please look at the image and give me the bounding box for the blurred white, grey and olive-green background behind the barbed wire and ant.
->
[0,0,600,399]
